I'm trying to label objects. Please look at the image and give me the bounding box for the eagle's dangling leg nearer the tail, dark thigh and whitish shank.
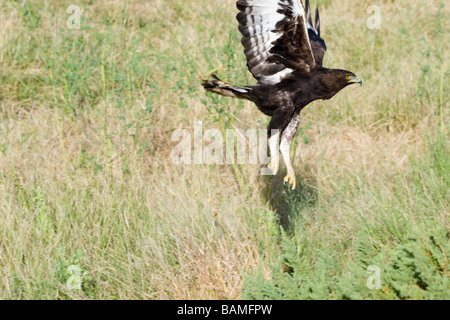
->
[267,108,293,175]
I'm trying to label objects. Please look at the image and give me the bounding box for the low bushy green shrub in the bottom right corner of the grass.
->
[243,227,450,300]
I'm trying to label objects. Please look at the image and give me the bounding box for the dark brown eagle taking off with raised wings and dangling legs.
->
[202,0,362,189]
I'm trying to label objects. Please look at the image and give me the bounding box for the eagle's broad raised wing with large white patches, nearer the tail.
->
[237,0,316,84]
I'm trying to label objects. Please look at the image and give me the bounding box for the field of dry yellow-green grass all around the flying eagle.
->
[0,0,450,299]
